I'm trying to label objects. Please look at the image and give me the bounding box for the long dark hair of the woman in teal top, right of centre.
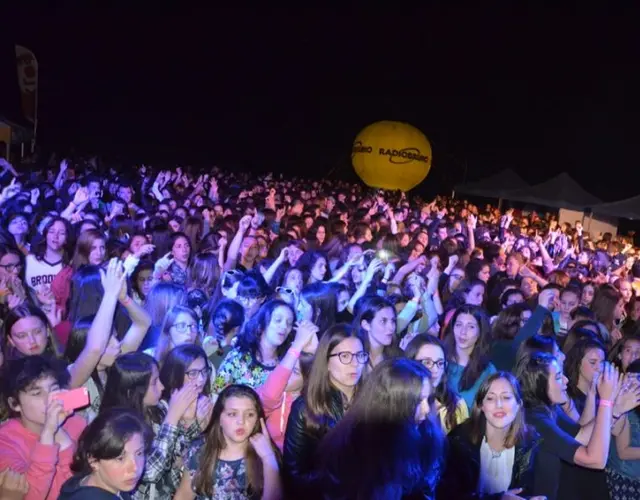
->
[444,305,491,391]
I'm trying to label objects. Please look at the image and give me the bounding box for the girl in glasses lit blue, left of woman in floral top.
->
[145,305,201,366]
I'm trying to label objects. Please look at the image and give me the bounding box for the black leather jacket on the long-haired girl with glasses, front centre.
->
[283,389,344,499]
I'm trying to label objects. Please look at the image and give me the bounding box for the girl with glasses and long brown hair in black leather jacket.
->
[283,324,369,498]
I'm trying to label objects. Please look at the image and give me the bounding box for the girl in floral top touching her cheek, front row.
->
[174,385,282,500]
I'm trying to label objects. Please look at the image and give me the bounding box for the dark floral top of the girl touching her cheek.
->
[184,440,260,500]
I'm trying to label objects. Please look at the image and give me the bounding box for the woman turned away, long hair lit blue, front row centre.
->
[317,358,443,499]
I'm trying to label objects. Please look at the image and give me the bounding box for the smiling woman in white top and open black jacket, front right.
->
[438,372,544,500]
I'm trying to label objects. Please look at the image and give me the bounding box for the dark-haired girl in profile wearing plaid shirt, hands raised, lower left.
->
[100,352,204,500]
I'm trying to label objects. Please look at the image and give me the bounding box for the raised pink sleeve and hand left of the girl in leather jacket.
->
[257,365,297,451]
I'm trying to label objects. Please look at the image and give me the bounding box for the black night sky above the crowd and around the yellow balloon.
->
[2,8,640,200]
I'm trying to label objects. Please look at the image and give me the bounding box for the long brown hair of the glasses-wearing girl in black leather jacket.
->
[304,323,364,429]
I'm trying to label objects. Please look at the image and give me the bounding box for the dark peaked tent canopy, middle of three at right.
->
[503,172,602,210]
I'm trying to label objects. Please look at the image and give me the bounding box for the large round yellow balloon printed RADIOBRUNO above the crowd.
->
[351,121,431,191]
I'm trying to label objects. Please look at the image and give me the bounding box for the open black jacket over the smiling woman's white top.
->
[437,420,540,500]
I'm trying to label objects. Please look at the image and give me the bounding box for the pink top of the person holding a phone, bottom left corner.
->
[0,415,87,500]
